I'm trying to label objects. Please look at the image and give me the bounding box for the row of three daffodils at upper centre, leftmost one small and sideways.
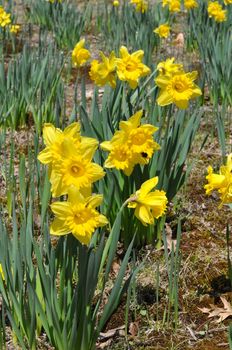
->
[72,39,150,89]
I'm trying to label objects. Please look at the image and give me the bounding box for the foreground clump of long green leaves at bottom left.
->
[0,133,135,350]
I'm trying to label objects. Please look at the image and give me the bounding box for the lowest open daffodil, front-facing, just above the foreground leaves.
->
[50,187,108,245]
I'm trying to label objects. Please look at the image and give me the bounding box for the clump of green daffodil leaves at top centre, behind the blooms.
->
[97,1,168,65]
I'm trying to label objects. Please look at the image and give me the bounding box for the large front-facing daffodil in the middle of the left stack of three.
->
[50,139,105,197]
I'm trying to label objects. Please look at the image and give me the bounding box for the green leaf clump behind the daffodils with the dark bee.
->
[77,79,202,246]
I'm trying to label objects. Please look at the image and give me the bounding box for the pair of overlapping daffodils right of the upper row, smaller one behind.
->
[155,58,202,109]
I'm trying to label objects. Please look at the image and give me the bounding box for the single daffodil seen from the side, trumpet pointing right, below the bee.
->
[128,177,168,226]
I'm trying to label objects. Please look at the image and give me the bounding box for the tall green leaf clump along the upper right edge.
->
[188,2,232,157]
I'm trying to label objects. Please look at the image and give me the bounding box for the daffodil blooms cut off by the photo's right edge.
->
[204,153,232,207]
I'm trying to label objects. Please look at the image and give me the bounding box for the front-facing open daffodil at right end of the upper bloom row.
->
[155,72,202,109]
